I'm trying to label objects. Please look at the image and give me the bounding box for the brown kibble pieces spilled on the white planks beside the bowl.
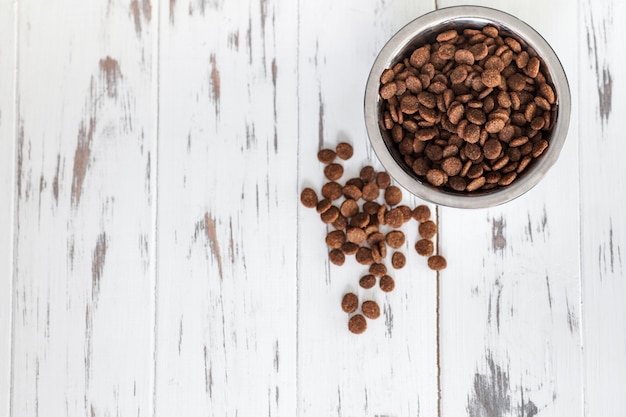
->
[300,142,447,334]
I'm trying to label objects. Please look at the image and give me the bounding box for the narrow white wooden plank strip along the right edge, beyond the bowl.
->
[579,0,626,416]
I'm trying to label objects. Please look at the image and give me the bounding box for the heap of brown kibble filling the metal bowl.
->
[379,26,557,193]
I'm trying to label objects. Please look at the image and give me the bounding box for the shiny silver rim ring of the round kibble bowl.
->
[364,6,571,208]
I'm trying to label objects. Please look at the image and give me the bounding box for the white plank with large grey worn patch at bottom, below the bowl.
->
[439,1,583,416]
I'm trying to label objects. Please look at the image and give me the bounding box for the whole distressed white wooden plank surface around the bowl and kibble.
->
[0,0,626,417]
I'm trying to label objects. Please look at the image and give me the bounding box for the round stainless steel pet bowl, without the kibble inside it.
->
[365,6,571,208]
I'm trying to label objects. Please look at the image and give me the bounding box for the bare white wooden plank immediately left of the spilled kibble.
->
[155,0,298,417]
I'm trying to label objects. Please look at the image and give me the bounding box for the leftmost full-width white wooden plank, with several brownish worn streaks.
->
[11,0,156,416]
